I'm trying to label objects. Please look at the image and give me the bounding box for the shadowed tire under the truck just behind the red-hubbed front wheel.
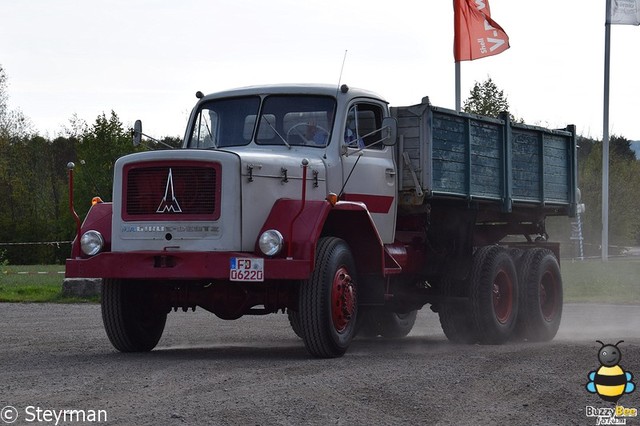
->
[358,309,418,339]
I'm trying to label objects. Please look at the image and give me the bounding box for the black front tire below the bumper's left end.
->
[101,279,167,352]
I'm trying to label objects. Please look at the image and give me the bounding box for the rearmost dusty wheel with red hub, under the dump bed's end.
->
[516,248,563,342]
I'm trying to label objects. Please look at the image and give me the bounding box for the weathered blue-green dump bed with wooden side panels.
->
[392,98,577,216]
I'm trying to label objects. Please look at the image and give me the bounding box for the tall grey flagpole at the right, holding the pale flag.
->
[602,0,611,262]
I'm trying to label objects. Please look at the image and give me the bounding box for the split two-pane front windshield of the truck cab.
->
[187,95,335,149]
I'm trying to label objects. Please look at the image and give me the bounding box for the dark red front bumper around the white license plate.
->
[65,251,313,281]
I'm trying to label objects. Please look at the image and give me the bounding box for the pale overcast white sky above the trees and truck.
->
[0,0,640,140]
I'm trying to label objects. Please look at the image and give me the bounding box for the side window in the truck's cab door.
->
[344,103,384,149]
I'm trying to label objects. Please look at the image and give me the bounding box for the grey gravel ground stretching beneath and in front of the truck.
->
[0,304,640,425]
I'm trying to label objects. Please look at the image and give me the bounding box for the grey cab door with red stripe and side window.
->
[341,100,397,243]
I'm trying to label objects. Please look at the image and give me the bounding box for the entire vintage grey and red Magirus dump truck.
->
[66,85,577,357]
